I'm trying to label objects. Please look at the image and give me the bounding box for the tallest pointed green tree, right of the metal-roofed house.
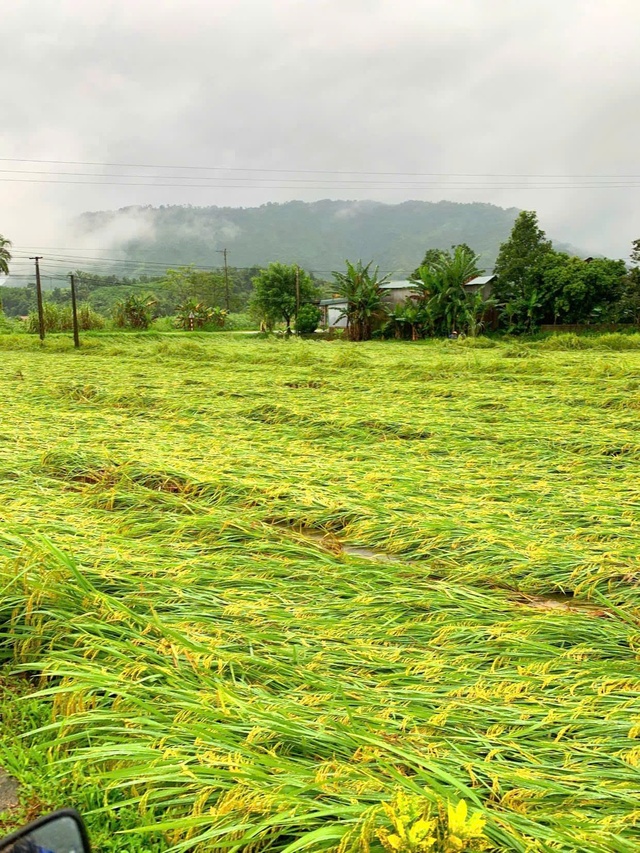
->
[494,210,553,306]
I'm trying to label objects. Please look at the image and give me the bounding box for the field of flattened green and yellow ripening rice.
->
[0,335,640,853]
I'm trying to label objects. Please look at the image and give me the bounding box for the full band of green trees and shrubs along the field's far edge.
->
[0,211,640,340]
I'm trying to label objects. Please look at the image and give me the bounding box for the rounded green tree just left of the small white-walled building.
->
[251,263,318,334]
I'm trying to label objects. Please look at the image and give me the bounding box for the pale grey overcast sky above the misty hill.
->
[0,0,640,264]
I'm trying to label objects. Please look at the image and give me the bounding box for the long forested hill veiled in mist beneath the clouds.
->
[76,200,584,277]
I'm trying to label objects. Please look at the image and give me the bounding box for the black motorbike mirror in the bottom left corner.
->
[0,809,91,853]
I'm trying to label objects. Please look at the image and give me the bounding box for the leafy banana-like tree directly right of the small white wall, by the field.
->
[333,261,388,341]
